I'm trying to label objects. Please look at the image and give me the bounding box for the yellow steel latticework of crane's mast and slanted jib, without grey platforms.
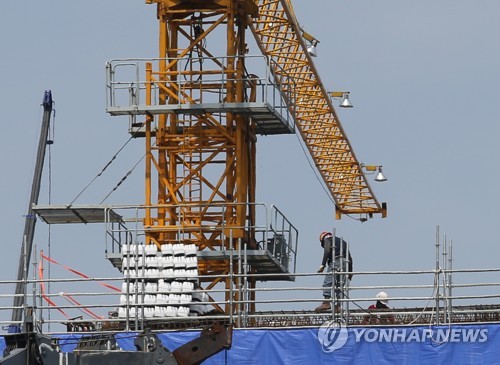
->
[139,0,385,312]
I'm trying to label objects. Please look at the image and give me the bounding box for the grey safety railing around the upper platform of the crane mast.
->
[106,55,295,130]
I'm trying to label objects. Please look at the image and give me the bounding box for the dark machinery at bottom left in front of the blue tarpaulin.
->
[0,311,231,365]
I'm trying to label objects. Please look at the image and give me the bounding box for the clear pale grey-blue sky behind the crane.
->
[0,0,500,314]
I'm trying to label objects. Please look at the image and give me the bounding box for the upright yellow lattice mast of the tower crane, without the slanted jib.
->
[144,0,257,312]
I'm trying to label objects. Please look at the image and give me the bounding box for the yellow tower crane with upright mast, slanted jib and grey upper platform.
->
[101,0,386,312]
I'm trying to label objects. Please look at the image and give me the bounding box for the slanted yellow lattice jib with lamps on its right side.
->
[251,0,387,219]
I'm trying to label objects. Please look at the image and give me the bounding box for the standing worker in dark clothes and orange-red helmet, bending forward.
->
[314,232,352,312]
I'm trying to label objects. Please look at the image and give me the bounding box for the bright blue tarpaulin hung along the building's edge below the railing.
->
[0,324,500,365]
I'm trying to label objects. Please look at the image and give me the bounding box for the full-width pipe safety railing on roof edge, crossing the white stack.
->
[0,264,500,333]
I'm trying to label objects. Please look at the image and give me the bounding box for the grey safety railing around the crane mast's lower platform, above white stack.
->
[104,203,298,273]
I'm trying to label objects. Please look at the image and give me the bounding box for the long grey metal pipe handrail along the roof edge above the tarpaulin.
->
[0,264,500,332]
